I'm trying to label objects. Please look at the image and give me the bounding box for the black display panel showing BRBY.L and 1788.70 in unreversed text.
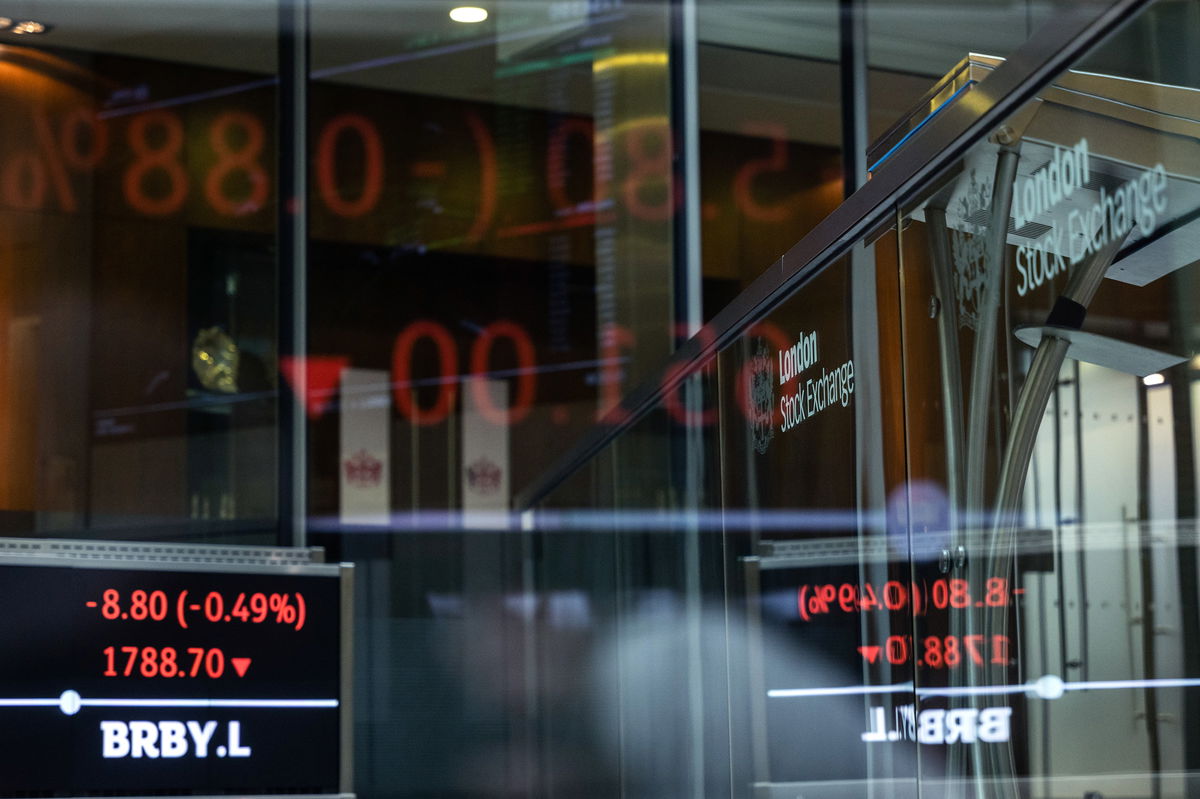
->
[0,554,346,797]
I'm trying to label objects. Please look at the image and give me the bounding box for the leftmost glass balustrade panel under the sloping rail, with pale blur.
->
[526,370,730,797]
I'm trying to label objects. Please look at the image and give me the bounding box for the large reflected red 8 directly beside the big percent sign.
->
[122,110,187,216]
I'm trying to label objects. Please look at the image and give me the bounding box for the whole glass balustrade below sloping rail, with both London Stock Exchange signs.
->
[535,5,1200,797]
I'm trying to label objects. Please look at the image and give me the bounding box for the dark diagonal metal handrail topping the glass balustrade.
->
[514,0,1151,509]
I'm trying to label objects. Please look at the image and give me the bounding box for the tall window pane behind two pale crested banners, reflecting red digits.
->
[308,0,690,797]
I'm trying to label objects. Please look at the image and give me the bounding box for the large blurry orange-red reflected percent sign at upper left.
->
[0,108,108,211]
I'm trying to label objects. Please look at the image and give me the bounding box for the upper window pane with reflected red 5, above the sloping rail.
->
[697,0,844,304]
